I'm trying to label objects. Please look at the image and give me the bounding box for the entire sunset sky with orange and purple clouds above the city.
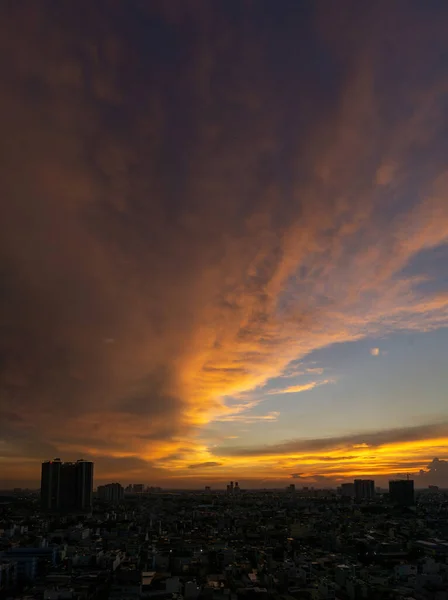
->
[0,0,448,488]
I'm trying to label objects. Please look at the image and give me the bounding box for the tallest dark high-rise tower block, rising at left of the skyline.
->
[40,458,93,512]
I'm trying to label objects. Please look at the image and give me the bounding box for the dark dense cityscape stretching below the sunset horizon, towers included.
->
[0,458,448,600]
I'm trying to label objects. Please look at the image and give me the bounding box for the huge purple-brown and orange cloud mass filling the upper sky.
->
[0,0,448,480]
